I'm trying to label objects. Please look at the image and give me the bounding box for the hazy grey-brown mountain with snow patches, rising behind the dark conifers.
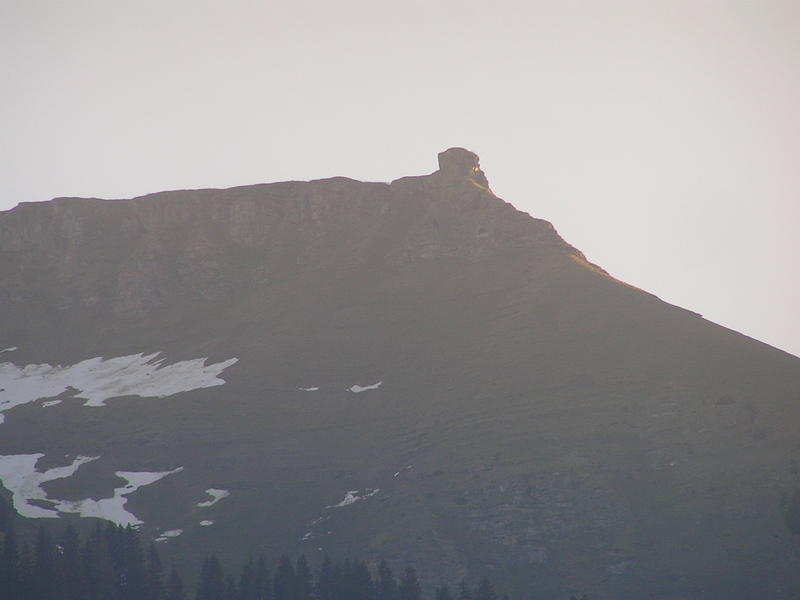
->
[0,148,800,600]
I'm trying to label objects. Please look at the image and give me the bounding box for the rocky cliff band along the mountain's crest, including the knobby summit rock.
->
[0,149,563,316]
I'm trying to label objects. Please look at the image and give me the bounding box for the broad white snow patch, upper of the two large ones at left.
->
[0,349,238,422]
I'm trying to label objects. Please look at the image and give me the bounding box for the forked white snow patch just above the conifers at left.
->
[0,454,183,526]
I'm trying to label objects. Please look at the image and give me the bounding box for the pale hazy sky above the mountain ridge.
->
[0,0,800,355]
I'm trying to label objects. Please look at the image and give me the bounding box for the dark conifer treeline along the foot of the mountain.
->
[0,512,507,600]
